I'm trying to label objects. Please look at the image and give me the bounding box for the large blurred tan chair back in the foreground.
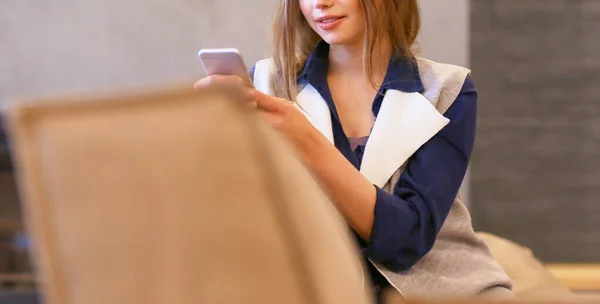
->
[2,85,371,304]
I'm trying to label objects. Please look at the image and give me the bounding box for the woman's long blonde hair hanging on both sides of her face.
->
[270,0,421,101]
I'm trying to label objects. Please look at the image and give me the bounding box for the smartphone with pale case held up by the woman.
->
[198,48,253,87]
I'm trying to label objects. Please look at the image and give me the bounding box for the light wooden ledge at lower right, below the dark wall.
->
[546,264,600,291]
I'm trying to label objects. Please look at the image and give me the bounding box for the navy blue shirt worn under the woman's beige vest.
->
[251,42,477,300]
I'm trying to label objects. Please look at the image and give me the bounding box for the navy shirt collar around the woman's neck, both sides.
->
[298,40,425,93]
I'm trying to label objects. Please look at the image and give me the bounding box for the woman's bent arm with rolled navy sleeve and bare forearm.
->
[292,78,477,270]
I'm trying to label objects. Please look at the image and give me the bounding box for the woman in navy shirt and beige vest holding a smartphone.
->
[196,0,513,298]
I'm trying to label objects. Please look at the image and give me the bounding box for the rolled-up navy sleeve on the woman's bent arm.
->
[364,76,477,271]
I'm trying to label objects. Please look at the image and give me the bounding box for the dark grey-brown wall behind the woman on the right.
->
[471,0,600,262]
